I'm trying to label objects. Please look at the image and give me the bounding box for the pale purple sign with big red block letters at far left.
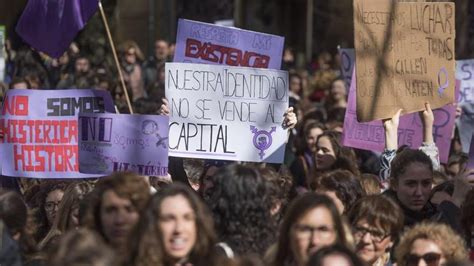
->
[0,89,114,178]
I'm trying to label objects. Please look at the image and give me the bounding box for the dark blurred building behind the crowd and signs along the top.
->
[0,0,474,66]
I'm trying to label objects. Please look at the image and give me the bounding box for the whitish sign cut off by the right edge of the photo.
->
[456,59,474,153]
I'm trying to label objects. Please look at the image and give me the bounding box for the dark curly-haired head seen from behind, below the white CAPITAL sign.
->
[204,164,276,257]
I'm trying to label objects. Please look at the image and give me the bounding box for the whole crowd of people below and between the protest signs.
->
[0,34,474,266]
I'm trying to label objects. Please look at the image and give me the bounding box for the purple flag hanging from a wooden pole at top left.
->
[16,0,99,58]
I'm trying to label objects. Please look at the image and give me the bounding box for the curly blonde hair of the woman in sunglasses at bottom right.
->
[395,222,468,265]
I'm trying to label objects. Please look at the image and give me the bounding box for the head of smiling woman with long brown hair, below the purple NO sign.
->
[128,183,216,265]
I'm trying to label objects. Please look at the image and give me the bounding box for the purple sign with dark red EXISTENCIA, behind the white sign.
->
[173,19,285,69]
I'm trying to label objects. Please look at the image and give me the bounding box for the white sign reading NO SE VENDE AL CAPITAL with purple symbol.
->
[165,63,288,163]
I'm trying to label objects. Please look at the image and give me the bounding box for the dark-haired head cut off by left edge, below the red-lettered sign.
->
[0,190,28,241]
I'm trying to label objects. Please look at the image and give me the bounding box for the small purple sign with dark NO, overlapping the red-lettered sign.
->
[79,114,169,176]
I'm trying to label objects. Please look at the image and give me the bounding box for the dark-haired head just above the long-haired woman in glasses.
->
[315,170,365,215]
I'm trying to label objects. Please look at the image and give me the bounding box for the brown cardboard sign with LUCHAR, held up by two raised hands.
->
[354,0,455,122]
